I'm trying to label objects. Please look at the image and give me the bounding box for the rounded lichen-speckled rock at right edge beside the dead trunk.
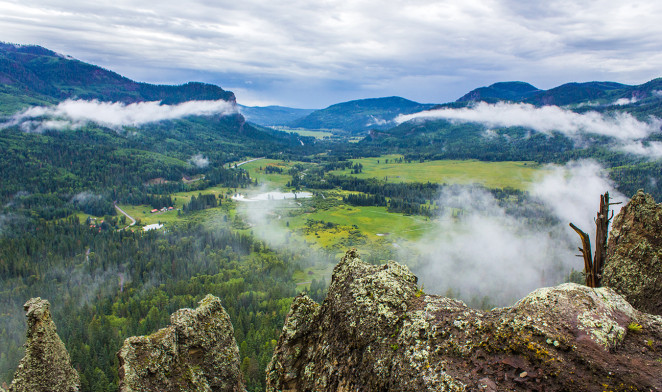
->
[602,191,662,315]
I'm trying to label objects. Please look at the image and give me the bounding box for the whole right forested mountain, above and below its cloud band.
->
[364,78,662,199]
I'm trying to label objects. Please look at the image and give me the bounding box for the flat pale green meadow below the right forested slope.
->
[334,155,541,189]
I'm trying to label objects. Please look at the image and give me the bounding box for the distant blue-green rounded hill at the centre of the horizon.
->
[290,97,434,133]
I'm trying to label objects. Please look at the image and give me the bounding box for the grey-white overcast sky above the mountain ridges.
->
[0,0,662,108]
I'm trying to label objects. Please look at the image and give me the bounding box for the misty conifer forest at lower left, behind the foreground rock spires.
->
[0,216,325,391]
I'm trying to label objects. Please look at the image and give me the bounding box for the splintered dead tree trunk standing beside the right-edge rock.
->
[570,192,620,287]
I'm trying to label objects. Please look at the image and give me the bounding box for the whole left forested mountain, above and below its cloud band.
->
[0,44,313,219]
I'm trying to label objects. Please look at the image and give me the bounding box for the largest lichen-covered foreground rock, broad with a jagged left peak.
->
[267,250,662,391]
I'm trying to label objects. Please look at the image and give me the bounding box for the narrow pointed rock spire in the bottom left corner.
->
[9,298,80,392]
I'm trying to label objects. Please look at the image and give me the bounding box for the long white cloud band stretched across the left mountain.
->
[0,99,237,132]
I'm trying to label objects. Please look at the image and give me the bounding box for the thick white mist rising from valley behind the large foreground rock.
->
[410,161,627,306]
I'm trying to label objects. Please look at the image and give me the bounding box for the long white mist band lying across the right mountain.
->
[395,101,662,157]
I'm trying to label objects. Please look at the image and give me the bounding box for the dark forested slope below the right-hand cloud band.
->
[360,121,662,200]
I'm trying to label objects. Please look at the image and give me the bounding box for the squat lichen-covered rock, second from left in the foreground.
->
[117,295,245,392]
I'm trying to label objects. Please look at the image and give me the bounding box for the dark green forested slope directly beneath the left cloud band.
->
[0,114,286,220]
